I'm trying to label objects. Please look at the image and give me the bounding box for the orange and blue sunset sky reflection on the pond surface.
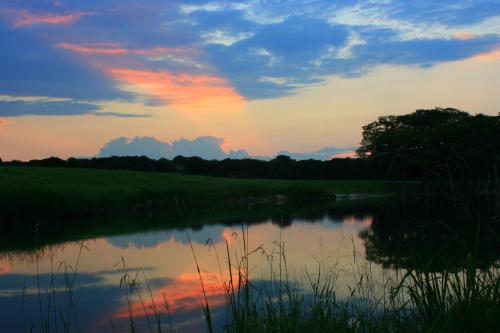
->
[0,215,381,332]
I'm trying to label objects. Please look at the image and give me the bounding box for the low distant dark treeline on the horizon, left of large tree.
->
[2,155,385,179]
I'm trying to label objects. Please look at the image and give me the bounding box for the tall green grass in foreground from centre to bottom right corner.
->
[192,230,500,333]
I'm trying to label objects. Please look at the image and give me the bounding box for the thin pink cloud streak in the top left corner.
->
[6,10,94,27]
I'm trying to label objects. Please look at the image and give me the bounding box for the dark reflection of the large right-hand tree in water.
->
[360,197,500,271]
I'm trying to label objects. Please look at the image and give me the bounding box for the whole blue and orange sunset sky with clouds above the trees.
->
[0,0,500,160]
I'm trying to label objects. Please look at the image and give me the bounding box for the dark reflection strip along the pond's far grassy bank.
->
[0,200,381,255]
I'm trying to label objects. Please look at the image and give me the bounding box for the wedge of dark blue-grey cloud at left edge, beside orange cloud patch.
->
[0,29,132,100]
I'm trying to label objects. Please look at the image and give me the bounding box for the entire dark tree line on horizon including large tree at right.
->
[0,108,500,184]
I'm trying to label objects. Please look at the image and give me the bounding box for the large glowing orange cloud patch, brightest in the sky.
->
[109,68,244,110]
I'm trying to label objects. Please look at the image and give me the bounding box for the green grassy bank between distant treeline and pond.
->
[0,167,389,222]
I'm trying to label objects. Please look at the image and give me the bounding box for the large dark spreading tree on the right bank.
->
[357,108,500,198]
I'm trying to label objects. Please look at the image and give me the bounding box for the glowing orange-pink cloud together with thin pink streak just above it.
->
[56,42,221,110]
